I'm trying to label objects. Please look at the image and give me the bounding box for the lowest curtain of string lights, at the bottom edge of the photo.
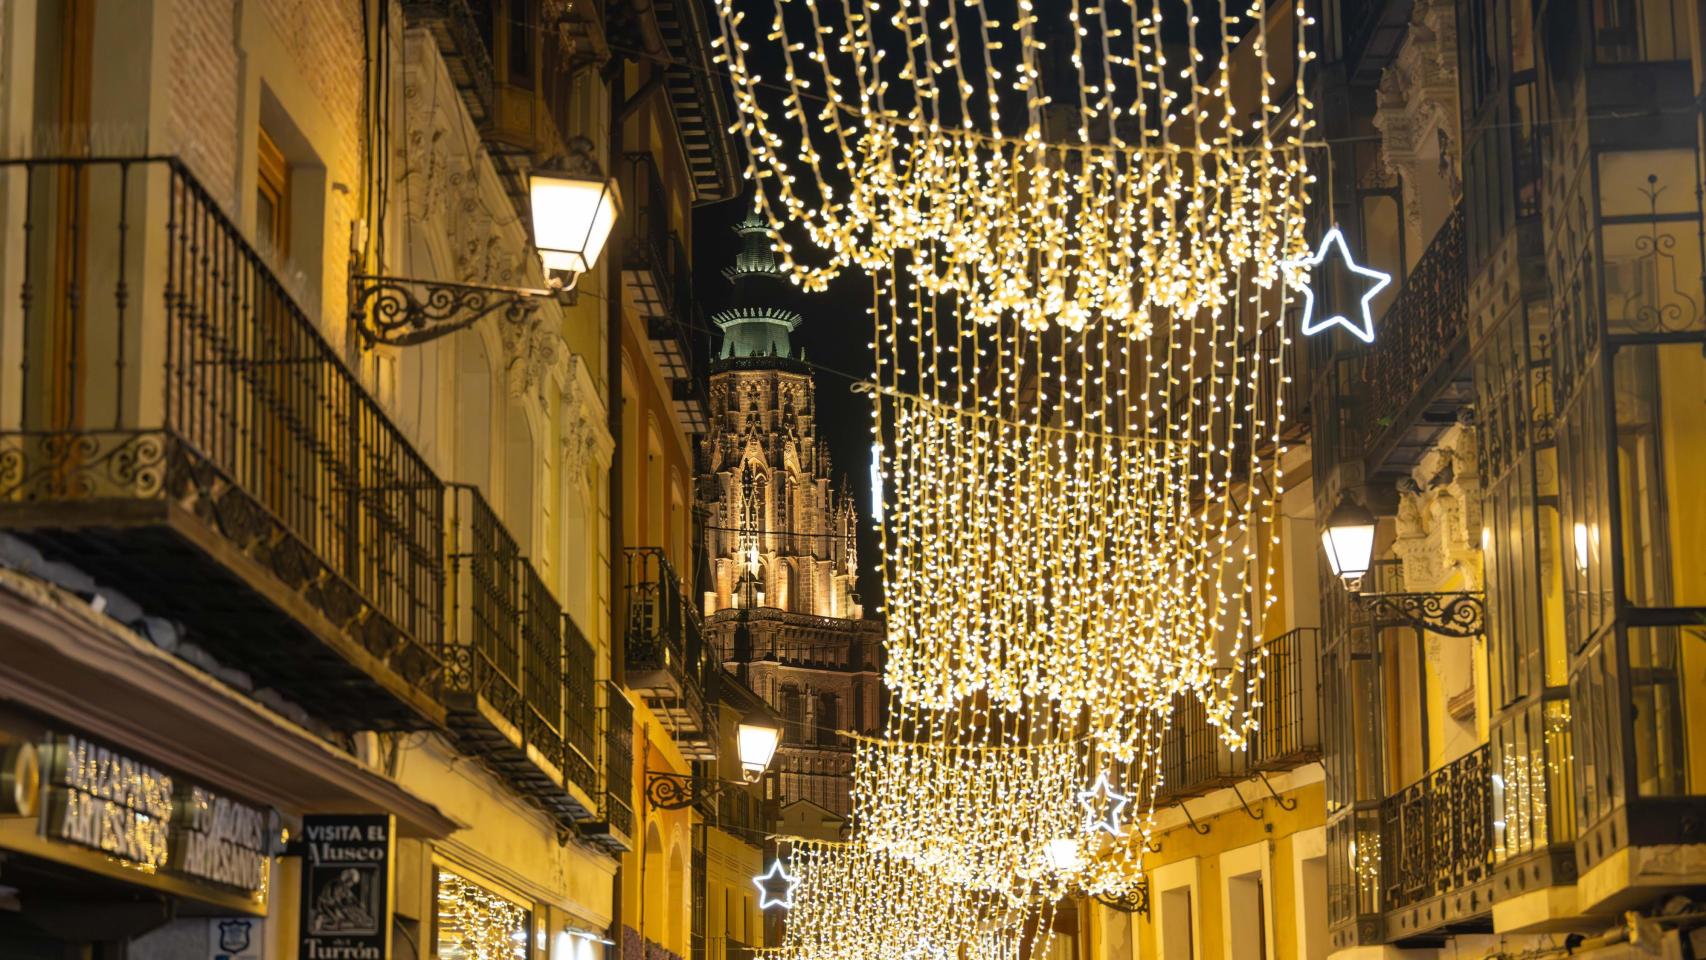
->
[766,837,1053,960]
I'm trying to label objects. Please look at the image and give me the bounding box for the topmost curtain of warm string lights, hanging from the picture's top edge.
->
[715,0,1310,329]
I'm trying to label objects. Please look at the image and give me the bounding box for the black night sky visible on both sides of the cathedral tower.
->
[693,195,882,616]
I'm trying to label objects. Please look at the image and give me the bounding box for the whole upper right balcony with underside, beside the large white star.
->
[1351,205,1474,472]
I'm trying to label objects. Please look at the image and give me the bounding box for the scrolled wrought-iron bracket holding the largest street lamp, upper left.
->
[350,273,575,346]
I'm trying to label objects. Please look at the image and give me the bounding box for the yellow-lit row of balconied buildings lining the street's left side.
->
[0,0,757,960]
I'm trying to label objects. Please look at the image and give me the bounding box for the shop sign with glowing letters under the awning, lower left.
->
[41,733,276,893]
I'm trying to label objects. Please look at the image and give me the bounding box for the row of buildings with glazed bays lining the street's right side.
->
[1076,0,1706,960]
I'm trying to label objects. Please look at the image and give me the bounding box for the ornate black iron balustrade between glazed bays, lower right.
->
[1380,743,1493,911]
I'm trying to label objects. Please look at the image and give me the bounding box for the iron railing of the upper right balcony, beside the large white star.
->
[1355,205,1469,452]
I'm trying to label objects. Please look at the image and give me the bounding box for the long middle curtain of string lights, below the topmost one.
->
[873,245,1288,762]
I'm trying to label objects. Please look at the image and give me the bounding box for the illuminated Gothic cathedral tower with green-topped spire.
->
[698,215,882,821]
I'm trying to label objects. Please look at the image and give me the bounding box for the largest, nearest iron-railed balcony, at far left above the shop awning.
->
[0,159,445,730]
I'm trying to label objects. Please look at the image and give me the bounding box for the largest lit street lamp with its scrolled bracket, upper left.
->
[350,138,623,346]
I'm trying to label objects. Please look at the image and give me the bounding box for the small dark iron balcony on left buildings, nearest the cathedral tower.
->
[624,547,717,760]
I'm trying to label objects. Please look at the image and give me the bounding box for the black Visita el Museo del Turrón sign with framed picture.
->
[300,813,394,960]
